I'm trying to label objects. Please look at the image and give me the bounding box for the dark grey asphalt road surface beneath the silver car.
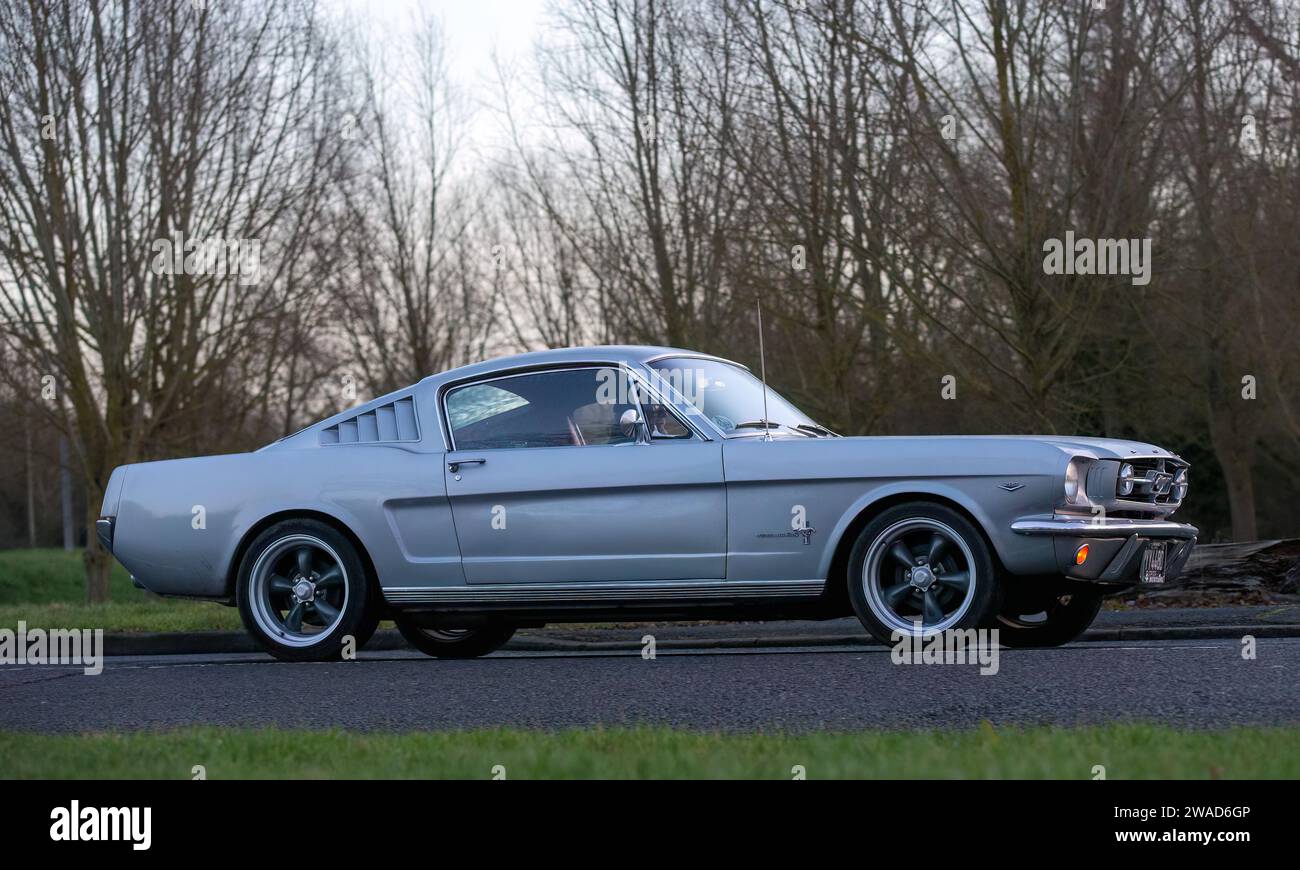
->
[0,639,1300,732]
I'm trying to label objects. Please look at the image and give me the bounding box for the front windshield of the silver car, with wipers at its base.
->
[650,356,829,434]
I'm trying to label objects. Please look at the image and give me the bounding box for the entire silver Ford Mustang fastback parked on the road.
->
[96,347,1196,661]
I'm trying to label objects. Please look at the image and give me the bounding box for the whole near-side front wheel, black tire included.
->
[848,502,1001,644]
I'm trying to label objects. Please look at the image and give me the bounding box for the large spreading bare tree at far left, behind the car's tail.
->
[0,0,351,601]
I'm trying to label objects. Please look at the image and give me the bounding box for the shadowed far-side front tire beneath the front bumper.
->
[989,577,1104,648]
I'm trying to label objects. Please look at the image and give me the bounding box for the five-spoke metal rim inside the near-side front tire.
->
[862,518,979,635]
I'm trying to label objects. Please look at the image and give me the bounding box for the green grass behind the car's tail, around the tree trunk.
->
[0,549,239,632]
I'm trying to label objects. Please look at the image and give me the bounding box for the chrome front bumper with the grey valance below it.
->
[1011,516,1197,585]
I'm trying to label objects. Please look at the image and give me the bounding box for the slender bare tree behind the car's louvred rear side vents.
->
[330,14,499,393]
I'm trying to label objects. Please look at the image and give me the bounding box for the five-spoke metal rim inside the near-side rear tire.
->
[248,534,348,648]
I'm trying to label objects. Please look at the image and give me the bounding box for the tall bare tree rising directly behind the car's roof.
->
[525,0,740,347]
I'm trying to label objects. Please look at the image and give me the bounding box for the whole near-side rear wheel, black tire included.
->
[235,519,378,662]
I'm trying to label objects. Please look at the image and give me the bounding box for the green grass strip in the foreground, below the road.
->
[0,724,1300,780]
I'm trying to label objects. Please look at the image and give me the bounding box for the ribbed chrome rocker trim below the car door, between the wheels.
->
[384,580,826,603]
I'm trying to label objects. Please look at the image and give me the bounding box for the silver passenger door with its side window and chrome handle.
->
[439,367,727,584]
